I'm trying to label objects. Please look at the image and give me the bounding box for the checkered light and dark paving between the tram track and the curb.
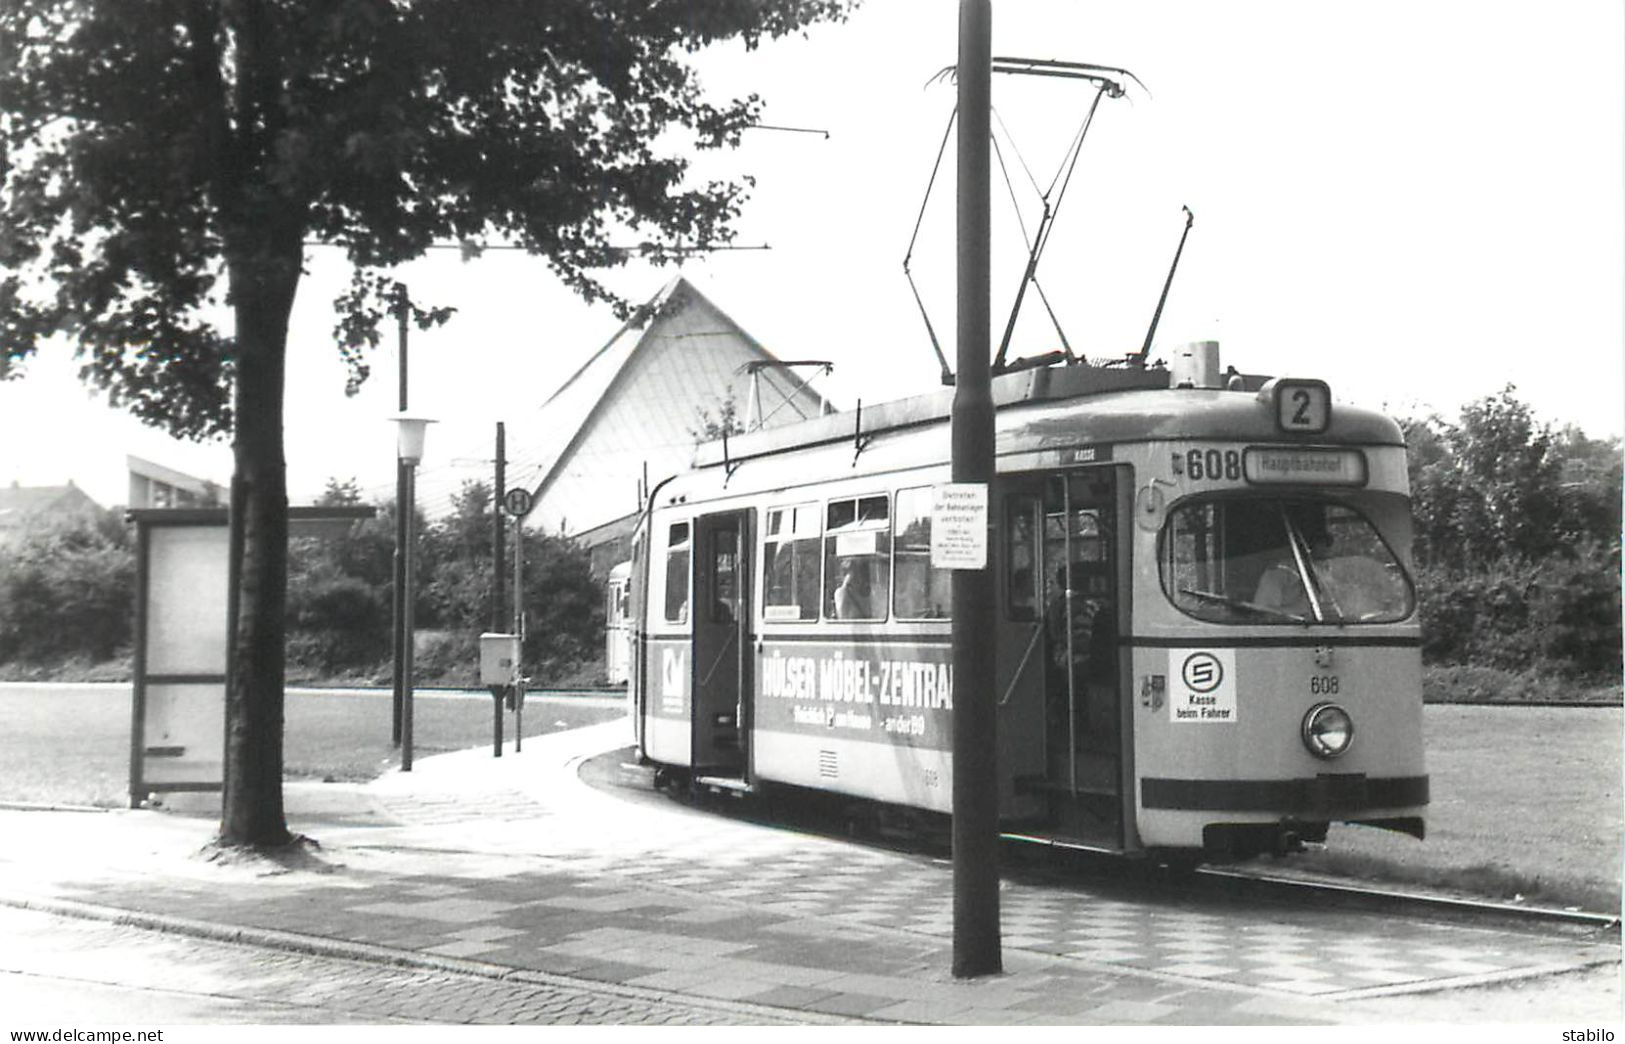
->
[86,741,1592,1021]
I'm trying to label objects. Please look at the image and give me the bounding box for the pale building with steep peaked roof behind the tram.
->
[507,276,830,574]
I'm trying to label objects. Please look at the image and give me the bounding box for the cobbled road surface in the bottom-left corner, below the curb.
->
[0,907,776,1031]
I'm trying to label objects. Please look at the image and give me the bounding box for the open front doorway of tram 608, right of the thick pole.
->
[998,465,1133,849]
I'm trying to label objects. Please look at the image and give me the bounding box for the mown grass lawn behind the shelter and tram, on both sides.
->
[0,685,1625,912]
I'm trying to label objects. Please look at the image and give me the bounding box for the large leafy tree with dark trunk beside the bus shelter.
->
[0,0,845,846]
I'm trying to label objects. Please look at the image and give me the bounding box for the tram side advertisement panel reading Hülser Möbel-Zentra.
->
[756,642,954,750]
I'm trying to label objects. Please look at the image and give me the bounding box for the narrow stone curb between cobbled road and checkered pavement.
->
[0,894,884,1026]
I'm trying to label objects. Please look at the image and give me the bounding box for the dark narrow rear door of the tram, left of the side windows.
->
[692,511,751,777]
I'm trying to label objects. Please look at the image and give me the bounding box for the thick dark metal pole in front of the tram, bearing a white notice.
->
[951,0,1003,979]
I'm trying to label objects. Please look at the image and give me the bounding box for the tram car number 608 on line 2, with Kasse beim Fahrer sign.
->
[629,341,1428,859]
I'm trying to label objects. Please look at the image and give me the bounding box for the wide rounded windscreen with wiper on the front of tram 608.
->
[1159,498,1415,623]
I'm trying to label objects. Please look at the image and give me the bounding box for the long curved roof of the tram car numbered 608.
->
[694,357,1404,468]
